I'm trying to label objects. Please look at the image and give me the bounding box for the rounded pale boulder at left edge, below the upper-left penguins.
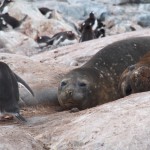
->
[0,30,39,56]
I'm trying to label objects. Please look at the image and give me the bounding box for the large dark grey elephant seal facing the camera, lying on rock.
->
[58,36,150,110]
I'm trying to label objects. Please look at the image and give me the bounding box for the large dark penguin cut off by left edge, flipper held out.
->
[0,62,34,122]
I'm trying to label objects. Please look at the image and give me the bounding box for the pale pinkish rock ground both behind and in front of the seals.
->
[0,30,150,150]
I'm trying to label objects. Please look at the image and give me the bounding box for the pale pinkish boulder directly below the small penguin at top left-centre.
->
[6,0,76,37]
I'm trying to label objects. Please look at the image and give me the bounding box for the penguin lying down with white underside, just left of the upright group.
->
[47,31,78,46]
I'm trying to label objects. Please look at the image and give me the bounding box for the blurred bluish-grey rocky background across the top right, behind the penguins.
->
[35,0,150,36]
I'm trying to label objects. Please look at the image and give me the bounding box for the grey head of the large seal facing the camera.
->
[58,67,99,110]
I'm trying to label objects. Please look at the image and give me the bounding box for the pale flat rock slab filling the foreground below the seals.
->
[0,92,150,150]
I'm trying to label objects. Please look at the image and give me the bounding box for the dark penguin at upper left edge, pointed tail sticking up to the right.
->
[0,13,28,29]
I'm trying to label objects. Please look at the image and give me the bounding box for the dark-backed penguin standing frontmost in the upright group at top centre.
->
[79,23,96,42]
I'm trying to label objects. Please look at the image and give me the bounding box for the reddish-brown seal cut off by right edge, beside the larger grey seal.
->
[119,52,150,97]
